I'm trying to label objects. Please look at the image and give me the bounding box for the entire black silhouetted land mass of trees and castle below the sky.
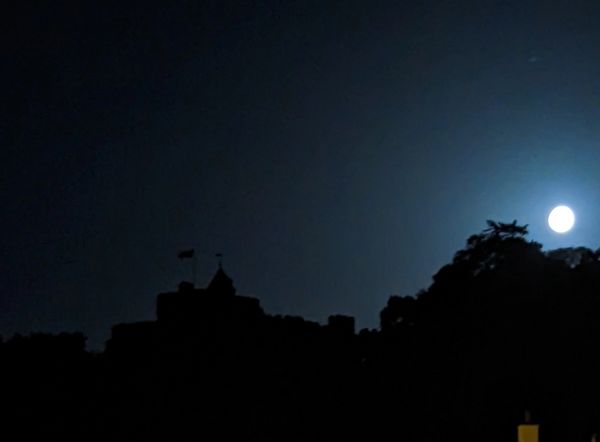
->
[0,221,600,442]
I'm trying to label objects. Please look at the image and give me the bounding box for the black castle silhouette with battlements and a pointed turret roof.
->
[106,264,355,358]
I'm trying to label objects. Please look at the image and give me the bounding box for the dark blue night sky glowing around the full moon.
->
[0,0,600,348]
